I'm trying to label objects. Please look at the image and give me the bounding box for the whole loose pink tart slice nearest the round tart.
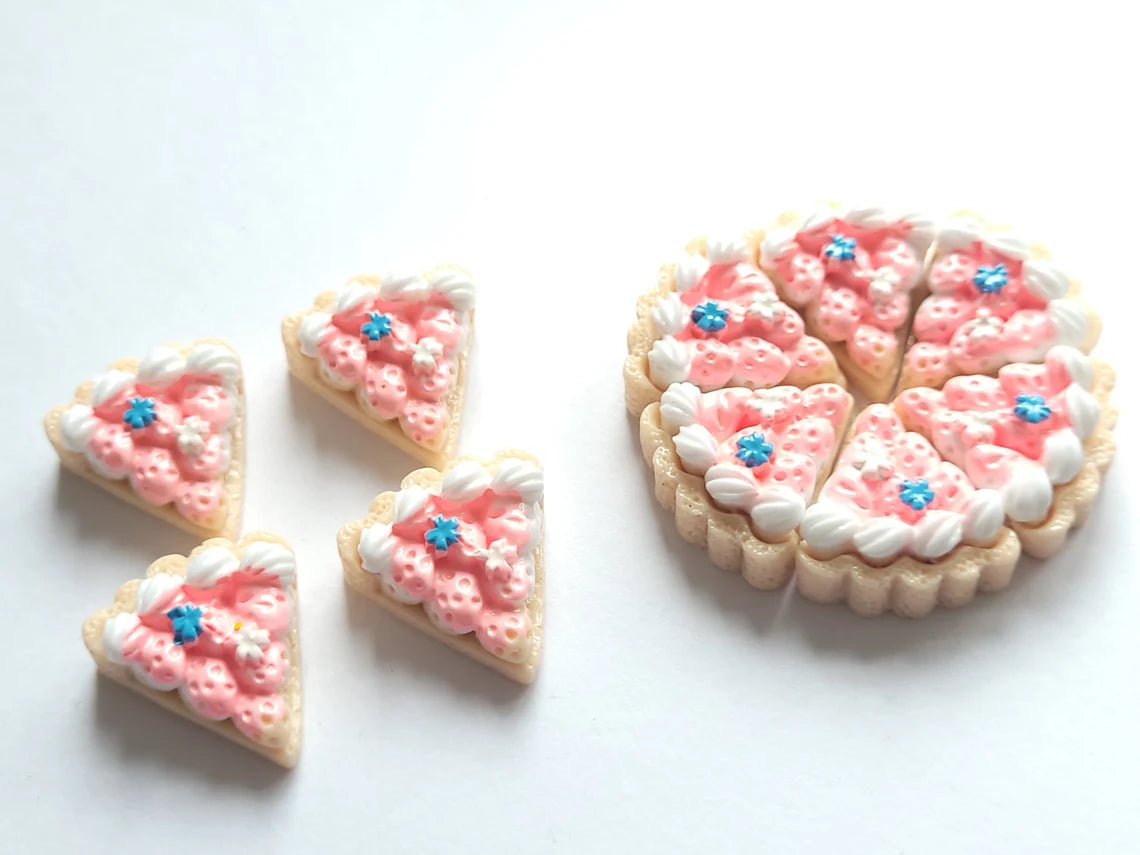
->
[336,450,544,683]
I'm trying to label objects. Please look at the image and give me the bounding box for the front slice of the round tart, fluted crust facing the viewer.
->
[796,404,1020,617]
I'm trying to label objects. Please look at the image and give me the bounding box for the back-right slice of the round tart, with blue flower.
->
[899,214,1100,389]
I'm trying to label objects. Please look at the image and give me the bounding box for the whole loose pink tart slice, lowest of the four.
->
[83,532,301,767]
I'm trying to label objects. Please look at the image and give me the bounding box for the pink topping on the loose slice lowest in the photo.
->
[110,570,293,741]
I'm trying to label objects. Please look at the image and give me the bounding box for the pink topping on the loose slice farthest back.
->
[317,294,466,445]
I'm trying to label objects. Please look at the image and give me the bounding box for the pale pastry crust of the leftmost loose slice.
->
[43,339,245,538]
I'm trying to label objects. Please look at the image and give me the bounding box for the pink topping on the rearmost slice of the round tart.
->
[775,220,922,373]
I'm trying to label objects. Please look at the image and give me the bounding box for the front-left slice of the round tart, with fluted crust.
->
[641,383,852,588]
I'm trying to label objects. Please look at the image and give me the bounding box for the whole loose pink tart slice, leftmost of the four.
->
[43,339,245,537]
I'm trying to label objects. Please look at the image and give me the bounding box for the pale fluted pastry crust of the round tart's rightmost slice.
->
[1011,361,1117,559]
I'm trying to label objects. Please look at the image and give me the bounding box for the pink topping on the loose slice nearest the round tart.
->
[378,490,538,658]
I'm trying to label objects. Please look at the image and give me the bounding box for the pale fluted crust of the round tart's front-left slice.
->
[641,404,850,591]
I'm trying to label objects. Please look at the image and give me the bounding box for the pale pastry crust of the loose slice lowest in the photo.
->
[83,531,301,768]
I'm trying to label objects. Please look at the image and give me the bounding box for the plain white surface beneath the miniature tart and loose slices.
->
[0,0,1140,855]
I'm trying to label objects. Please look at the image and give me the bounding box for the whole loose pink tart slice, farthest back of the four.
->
[282,267,475,467]
